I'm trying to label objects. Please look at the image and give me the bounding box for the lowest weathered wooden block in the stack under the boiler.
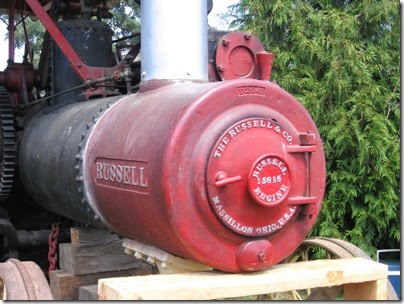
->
[50,267,152,301]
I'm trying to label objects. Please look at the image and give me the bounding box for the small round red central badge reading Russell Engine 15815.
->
[248,154,290,206]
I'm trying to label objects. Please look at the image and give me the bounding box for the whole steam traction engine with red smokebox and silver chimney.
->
[0,0,325,300]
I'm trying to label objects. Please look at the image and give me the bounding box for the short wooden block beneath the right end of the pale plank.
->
[344,279,387,301]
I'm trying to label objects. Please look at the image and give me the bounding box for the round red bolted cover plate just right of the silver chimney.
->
[215,32,266,80]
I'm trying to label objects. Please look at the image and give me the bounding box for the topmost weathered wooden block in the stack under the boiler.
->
[70,227,122,247]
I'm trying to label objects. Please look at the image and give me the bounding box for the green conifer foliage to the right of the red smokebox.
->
[236,0,400,255]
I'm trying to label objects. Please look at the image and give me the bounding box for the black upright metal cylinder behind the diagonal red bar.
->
[52,19,114,107]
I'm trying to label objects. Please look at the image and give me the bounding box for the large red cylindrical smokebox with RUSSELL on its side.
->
[83,79,325,272]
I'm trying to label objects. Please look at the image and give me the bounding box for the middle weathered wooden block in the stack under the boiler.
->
[59,242,145,275]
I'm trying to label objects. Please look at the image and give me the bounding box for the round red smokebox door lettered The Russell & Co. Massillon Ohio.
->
[206,117,297,237]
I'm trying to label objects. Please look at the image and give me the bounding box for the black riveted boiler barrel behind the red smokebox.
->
[20,96,121,227]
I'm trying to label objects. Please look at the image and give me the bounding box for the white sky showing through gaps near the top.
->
[0,0,240,71]
